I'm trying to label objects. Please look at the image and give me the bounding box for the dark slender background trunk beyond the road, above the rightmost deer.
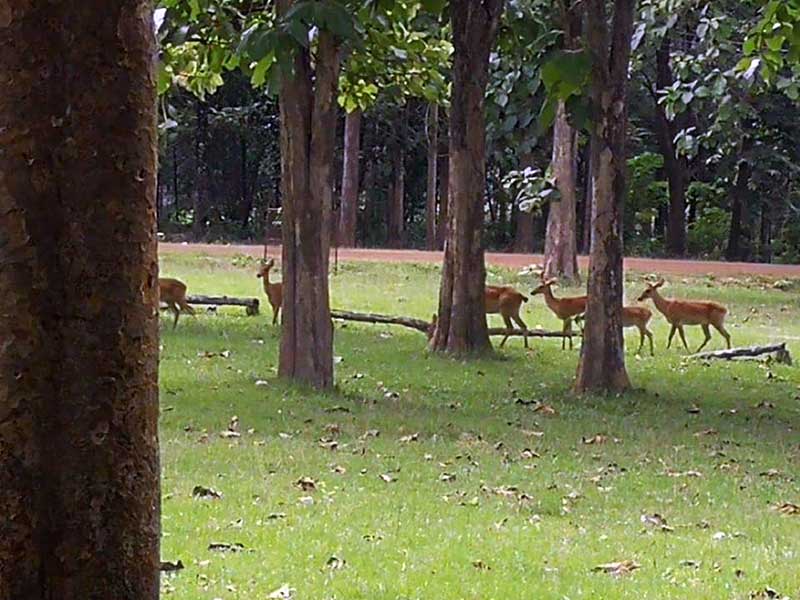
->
[654,34,689,256]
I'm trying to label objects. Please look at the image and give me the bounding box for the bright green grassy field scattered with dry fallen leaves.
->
[161,255,800,600]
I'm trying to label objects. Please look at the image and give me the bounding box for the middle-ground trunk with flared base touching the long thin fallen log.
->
[431,0,503,355]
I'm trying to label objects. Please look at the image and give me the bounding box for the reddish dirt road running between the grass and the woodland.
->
[159,243,800,278]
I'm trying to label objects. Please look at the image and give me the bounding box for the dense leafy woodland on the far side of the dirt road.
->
[158,0,800,262]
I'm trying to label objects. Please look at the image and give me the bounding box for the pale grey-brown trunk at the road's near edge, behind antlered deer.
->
[544,0,582,281]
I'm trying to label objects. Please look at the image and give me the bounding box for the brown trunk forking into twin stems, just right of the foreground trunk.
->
[278,0,339,388]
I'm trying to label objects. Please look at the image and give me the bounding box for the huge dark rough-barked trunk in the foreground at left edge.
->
[0,0,160,600]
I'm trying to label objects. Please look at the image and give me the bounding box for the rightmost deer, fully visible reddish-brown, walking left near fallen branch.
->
[639,279,731,352]
